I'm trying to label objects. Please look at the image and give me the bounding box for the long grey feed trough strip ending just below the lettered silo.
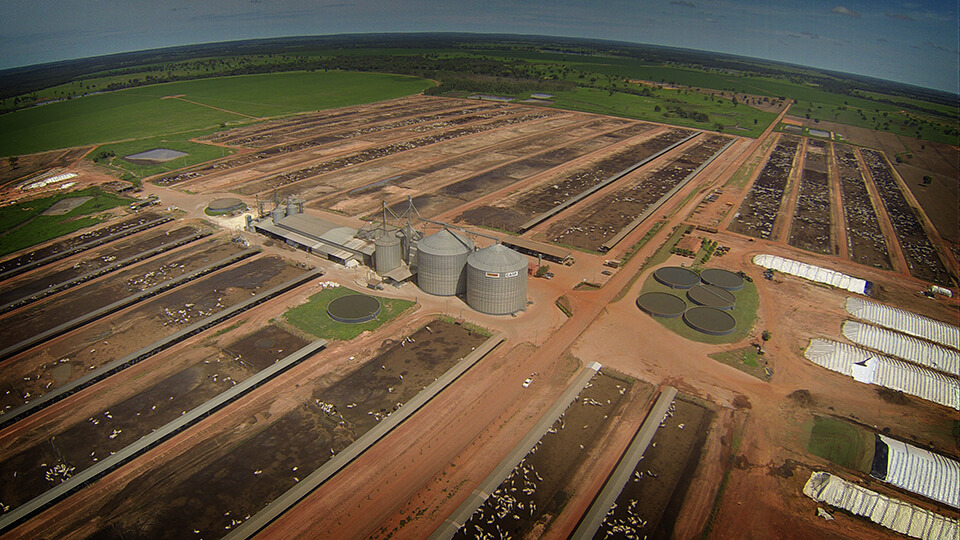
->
[224,333,510,540]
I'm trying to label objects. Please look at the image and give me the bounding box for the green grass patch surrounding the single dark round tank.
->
[283,287,416,341]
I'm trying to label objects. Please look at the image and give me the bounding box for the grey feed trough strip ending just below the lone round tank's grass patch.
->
[0,339,327,531]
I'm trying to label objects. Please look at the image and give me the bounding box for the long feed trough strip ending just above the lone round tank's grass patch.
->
[0,269,323,428]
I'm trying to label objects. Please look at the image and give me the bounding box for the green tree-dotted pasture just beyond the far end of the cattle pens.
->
[554,88,776,137]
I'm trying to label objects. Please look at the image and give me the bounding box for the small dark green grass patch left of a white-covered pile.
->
[807,416,876,474]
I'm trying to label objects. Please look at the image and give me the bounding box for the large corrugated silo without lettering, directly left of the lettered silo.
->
[417,229,474,296]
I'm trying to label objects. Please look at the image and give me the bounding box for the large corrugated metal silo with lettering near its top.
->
[467,244,527,315]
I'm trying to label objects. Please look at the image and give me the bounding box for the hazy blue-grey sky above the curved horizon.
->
[0,0,960,93]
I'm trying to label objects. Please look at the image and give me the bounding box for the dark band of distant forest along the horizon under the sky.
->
[0,34,957,109]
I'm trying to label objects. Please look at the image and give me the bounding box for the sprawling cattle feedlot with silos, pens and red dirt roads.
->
[0,78,960,539]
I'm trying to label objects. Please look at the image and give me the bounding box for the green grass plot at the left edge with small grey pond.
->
[0,187,133,257]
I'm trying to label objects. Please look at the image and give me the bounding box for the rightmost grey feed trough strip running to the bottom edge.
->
[571,386,677,540]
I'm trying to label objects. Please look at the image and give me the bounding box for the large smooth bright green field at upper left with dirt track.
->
[0,72,433,157]
